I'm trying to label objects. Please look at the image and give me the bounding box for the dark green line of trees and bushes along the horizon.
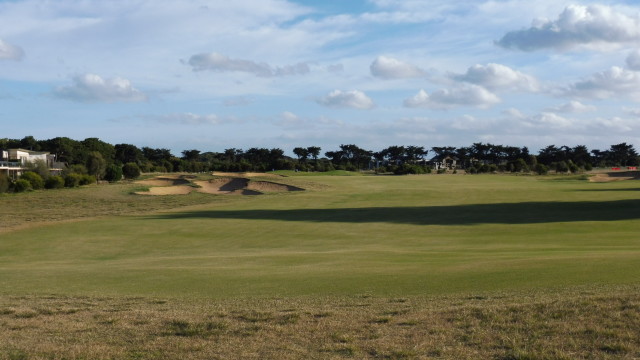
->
[0,136,639,192]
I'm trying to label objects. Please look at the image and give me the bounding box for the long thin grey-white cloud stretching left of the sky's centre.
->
[188,52,309,77]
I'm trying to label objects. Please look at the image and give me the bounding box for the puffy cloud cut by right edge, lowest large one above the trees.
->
[562,66,640,100]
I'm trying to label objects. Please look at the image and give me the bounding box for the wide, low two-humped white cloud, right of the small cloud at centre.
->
[404,85,500,109]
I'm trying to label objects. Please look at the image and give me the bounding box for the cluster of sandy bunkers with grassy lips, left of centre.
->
[136,173,304,195]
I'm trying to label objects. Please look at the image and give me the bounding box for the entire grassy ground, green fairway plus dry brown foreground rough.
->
[0,175,640,359]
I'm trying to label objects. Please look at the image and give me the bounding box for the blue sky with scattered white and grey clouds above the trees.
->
[0,0,640,155]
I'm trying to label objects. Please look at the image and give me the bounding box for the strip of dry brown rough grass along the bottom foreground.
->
[0,287,640,360]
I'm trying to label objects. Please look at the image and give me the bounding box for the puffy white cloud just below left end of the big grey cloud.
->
[452,63,539,91]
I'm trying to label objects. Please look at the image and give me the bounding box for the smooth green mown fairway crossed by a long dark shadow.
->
[0,175,640,298]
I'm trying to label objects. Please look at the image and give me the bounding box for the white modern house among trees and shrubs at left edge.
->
[0,149,64,179]
